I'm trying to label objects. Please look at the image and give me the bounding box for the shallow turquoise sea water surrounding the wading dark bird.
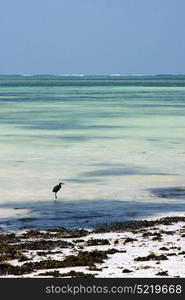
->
[0,75,185,229]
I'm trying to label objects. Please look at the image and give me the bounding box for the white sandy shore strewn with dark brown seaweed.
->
[0,215,185,278]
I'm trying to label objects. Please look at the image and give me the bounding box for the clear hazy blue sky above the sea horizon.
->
[0,0,185,75]
